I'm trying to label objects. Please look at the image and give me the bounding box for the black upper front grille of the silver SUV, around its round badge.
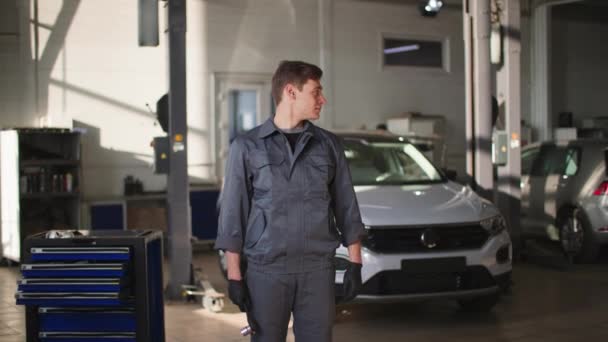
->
[363,224,489,253]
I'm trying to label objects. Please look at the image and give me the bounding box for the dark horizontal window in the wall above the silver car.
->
[382,37,444,69]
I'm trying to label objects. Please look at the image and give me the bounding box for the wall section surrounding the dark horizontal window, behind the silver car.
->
[330,0,465,174]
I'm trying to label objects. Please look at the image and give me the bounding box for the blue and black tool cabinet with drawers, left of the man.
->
[15,230,165,342]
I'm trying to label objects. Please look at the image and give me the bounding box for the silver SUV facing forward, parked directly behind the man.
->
[220,132,512,311]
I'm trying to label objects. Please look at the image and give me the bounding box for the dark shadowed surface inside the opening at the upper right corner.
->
[552,7,608,126]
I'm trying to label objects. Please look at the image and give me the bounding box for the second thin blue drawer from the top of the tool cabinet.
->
[21,263,126,278]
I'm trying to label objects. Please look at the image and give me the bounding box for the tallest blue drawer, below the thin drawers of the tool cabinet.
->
[38,307,136,332]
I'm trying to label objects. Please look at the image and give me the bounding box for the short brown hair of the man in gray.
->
[272,61,323,105]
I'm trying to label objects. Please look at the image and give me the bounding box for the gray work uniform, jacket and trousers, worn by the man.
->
[215,118,364,342]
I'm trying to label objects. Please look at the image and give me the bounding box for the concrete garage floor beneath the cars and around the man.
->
[0,251,608,342]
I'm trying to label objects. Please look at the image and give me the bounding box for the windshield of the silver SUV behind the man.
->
[344,138,444,185]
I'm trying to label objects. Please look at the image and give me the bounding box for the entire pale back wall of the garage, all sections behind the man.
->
[0,0,476,199]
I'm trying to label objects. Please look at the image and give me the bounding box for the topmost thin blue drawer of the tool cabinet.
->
[30,247,131,262]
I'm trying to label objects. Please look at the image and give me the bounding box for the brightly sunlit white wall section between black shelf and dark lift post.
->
[26,0,167,198]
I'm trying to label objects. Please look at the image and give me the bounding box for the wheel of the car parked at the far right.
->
[559,209,600,262]
